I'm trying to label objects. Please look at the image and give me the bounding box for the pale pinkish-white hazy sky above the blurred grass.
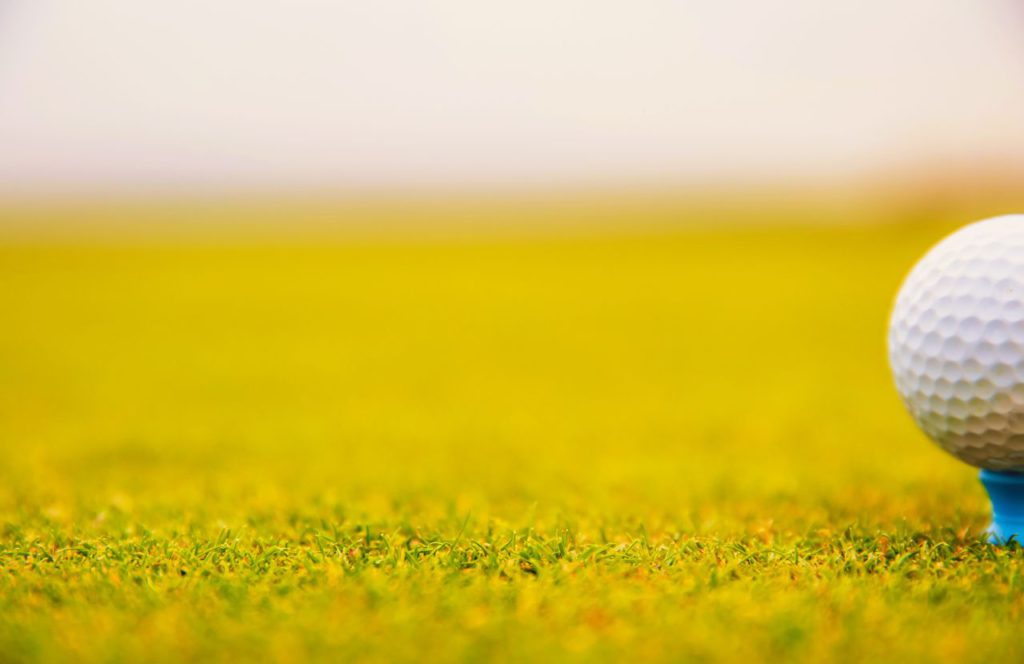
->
[0,0,1024,190]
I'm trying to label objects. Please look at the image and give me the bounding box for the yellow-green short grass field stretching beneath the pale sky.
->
[0,205,1024,662]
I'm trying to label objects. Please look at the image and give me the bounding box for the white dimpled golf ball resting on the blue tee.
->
[889,215,1024,471]
